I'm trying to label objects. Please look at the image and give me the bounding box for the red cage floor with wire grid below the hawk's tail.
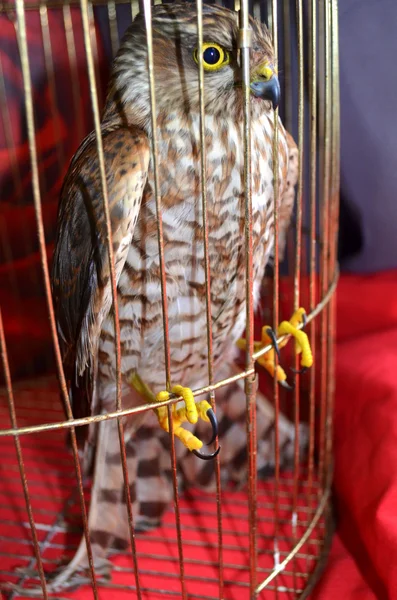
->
[0,379,324,600]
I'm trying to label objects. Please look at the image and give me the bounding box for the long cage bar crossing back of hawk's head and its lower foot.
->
[143,0,187,600]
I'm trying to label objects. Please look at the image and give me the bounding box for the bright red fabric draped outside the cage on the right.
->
[314,271,397,600]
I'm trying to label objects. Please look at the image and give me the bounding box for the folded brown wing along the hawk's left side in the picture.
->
[52,128,150,429]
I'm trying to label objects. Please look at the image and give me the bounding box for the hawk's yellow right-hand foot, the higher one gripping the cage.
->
[237,308,313,389]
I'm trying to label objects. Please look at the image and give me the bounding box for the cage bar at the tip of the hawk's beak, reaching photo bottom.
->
[269,0,280,599]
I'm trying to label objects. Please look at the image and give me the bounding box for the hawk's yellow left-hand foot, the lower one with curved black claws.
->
[156,385,220,460]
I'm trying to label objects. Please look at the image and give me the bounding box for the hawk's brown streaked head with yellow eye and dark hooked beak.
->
[107,4,280,126]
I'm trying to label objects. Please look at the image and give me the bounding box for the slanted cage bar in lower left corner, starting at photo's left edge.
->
[0,309,48,600]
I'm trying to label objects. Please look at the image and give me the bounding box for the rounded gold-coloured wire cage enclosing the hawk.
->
[0,0,339,600]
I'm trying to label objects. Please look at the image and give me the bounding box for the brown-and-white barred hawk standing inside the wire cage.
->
[44,4,311,591]
